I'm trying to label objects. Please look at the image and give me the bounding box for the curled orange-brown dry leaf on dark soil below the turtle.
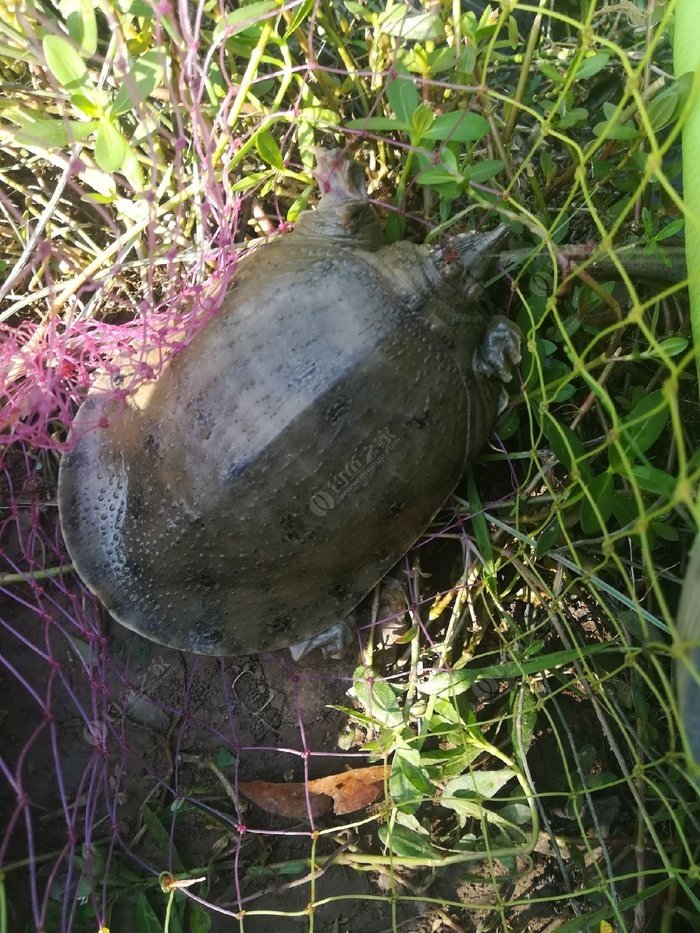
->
[238,765,386,820]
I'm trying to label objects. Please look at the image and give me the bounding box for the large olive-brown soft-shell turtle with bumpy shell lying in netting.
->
[58,151,519,655]
